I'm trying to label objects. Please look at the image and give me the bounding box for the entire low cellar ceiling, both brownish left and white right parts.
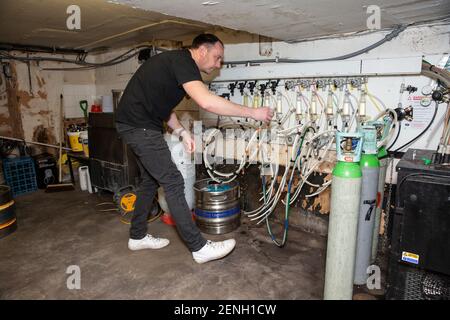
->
[0,0,450,50]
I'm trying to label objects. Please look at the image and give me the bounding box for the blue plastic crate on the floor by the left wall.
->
[2,157,37,196]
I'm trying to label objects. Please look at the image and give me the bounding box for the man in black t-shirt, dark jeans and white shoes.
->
[116,34,273,263]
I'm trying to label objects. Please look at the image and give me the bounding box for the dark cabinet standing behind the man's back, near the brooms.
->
[88,112,139,193]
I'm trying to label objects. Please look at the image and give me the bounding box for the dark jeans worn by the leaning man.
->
[117,123,206,252]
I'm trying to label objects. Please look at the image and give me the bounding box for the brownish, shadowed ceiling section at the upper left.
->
[0,0,243,50]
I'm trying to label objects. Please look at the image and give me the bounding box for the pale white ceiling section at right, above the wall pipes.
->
[114,0,450,42]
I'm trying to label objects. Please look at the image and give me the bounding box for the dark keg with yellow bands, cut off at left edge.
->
[0,185,17,239]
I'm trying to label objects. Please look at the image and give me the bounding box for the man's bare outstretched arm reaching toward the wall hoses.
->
[183,80,273,122]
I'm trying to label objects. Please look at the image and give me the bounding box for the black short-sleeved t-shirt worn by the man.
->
[116,49,202,131]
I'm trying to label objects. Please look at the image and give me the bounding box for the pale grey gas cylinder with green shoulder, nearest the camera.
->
[324,132,362,300]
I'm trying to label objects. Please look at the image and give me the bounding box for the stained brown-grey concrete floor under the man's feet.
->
[0,190,326,299]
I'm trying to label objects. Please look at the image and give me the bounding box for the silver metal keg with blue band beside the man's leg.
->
[194,179,241,234]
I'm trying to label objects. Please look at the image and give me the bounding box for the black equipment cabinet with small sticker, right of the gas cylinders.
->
[387,149,450,299]
